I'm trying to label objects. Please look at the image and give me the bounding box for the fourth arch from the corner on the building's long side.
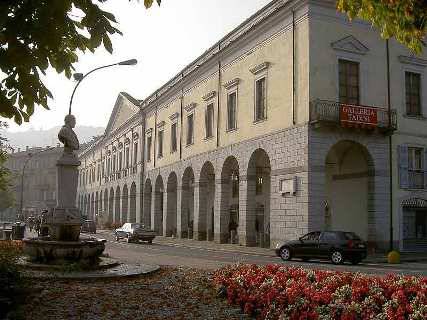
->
[181,167,195,239]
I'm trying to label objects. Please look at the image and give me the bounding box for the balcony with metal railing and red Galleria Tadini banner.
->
[310,99,397,133]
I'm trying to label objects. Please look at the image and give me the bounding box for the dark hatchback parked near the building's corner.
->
[276,231,367,264]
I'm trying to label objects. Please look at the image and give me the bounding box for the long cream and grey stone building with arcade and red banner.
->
[78,0,427,250]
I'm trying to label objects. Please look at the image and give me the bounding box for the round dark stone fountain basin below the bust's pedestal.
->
[23,237,106,264]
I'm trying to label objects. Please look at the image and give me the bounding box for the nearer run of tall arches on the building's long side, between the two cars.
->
[142,149,271,247]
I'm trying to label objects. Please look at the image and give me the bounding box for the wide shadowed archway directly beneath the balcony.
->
[324,140,375,242]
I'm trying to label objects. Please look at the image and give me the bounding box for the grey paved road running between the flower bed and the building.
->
[97,233,427,276]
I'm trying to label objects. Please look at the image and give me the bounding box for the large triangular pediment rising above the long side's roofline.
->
[105,92,139,136]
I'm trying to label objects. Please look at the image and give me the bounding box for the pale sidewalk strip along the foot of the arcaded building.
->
[97,230,427,263]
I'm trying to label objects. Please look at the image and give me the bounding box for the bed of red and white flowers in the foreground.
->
[213,265,427,320]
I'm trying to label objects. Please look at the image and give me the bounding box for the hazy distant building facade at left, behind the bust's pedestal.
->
[5,146,63,218]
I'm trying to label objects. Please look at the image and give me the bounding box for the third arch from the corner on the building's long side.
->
[196,161,215,241]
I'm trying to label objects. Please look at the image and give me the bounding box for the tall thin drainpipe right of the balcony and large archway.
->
[386,39,393,251]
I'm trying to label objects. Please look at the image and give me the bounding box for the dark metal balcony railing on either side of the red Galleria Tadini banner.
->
[310,99,397,131]
